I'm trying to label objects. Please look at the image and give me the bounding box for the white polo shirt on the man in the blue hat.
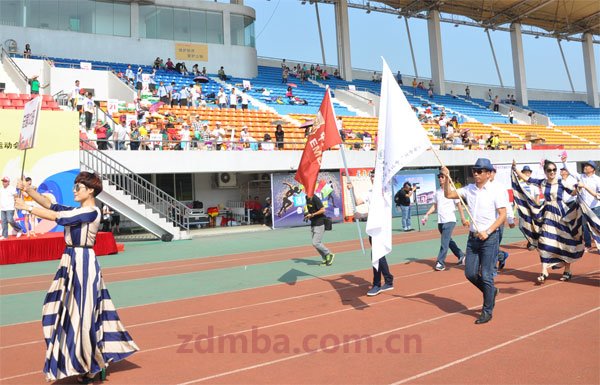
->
[457,182,506,231]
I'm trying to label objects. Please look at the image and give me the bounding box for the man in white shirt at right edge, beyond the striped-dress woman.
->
[561,154,600,251]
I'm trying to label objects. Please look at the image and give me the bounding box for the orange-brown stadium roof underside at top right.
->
[373,0,600,36]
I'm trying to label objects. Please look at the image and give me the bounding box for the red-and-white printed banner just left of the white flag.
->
[340,168,373,222]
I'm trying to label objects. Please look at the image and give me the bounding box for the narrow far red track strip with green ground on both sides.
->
[0,228,467,295]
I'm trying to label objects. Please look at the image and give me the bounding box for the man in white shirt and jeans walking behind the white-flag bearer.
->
[423,174,469,271]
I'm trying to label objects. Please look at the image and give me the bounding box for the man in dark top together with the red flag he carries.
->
[295,88,342,266]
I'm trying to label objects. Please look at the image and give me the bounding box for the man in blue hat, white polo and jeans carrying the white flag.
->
[441,158,506,324]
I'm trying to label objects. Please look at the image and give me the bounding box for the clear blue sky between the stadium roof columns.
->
[244,0,600,92]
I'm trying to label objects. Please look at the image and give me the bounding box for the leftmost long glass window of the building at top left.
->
[0,0,131,36]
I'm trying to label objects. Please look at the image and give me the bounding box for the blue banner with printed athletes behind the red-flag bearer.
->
[271,171,342,228]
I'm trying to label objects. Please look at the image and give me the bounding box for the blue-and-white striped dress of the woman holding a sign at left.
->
[42,204,139,381]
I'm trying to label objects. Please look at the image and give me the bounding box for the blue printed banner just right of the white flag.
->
[392,169,438,217]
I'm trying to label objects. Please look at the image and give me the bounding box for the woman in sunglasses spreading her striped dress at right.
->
[512,160,600,283]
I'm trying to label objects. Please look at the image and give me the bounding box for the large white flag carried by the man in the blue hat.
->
[367,58,431,269]
